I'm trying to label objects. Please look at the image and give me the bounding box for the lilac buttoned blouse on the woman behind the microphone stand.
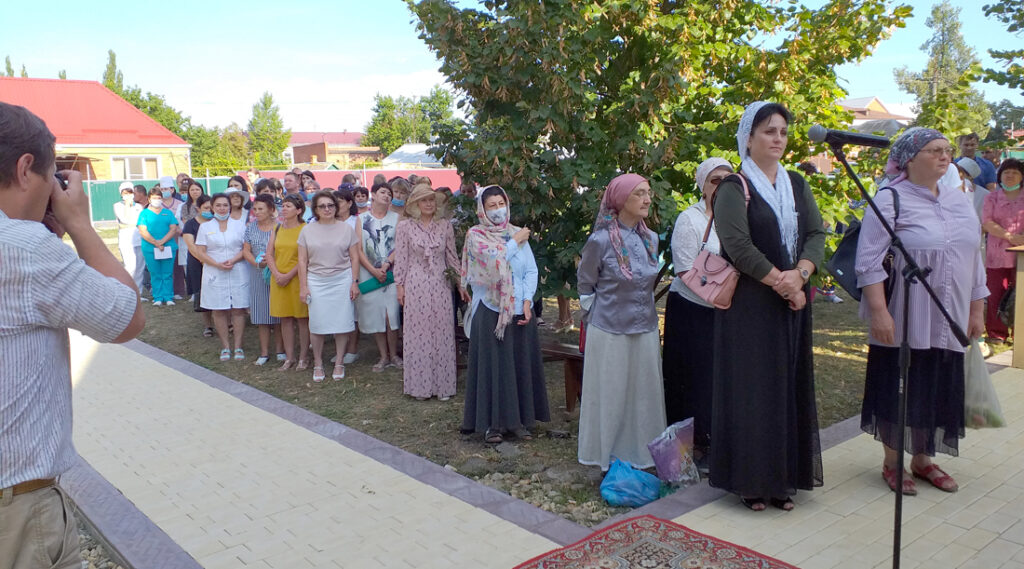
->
[856,180,988,352]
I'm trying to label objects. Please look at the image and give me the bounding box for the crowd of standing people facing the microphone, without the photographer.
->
[115,101,1024,511]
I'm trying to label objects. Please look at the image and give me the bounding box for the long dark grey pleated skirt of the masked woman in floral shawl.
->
[462,304,551,433]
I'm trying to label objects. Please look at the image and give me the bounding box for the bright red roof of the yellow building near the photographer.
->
[0,77,187,146]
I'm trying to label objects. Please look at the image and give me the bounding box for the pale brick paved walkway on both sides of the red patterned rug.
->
[68,334,1024,569]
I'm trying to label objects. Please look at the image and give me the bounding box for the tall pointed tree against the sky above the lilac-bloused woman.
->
[893,0,990,138]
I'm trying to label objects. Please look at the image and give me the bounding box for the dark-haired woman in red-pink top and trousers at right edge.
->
[981,158,1024,344]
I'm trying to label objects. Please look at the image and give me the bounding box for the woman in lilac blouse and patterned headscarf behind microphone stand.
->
[857,127,988,495]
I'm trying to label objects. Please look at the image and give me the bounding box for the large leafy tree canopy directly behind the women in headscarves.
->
[407,0,910,295]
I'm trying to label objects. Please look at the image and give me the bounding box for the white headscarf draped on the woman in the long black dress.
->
[736,100,800,261]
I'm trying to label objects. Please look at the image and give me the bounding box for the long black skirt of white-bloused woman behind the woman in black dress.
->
[662,293,715,448]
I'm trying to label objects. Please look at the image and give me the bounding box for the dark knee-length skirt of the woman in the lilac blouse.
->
[860,345,964,456]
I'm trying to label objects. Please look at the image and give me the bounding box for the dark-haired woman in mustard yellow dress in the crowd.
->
[265,193,309,371]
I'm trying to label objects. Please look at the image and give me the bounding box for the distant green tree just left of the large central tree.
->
[362,85,455,156]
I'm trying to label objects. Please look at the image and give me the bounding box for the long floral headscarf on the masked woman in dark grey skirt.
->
[462,185,519,340]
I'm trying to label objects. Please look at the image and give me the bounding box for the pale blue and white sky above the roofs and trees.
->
[0,0,1024,132]
